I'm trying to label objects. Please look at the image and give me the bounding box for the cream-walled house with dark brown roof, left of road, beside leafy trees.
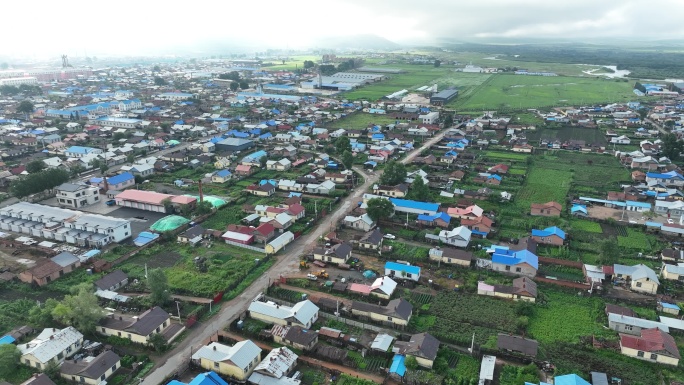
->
[95,306,185,345]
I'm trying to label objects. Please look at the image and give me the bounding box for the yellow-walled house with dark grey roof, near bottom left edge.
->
[59,350,121,385]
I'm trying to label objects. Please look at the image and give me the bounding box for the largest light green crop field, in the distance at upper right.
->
[449,74,635,111]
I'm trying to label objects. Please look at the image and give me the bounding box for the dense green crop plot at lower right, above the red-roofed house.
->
[527,288,614,343]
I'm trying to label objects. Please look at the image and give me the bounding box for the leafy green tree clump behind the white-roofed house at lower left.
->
[52,283,104,333]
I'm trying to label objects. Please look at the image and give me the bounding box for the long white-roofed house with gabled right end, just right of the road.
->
[247,300,318,329]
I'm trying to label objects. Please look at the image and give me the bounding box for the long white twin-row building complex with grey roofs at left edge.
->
[0,202,131,247]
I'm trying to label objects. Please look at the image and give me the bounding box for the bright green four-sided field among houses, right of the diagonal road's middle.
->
[515,167,572,210]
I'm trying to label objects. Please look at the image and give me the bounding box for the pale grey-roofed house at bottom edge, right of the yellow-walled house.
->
[248,346,300,385]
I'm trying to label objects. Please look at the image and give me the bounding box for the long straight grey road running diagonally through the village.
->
[142,127,446,385]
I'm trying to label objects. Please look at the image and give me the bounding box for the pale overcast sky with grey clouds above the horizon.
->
[0,0,684,56]
